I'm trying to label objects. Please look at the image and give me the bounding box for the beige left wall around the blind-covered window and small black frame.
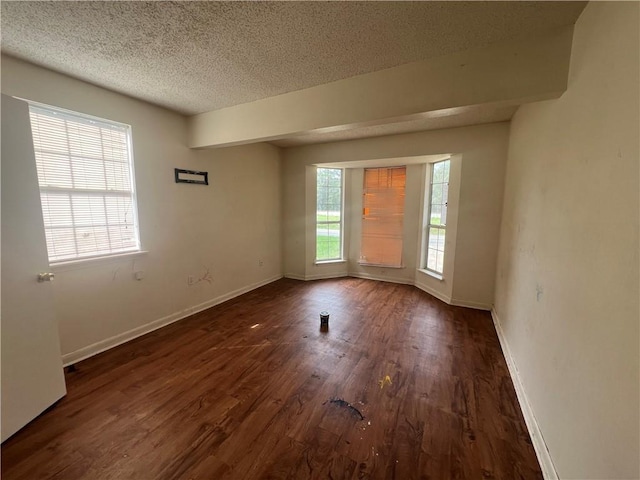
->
[2,57,282,363]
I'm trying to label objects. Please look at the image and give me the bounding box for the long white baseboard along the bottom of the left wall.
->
[62,275,282,367]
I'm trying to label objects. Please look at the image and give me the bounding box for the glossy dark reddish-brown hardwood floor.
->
[2,278,542,480]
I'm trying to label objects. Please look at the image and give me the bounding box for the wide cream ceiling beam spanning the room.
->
[189,27,573,148]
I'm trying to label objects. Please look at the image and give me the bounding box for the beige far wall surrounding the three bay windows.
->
[283,123,509,308]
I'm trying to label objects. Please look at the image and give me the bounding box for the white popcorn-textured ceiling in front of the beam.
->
[1,1,584,117]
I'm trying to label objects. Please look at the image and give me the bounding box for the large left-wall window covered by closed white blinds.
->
[29,104,140,263]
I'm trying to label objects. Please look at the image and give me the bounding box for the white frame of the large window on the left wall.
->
[25,99,141,267]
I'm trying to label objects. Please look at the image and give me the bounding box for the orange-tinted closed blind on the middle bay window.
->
[359,167,407,267]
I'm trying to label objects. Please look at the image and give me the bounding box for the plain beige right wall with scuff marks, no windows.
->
[496,2,640,479]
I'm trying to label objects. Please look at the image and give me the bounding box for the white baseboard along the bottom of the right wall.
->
[491,309,559,480]
